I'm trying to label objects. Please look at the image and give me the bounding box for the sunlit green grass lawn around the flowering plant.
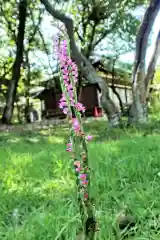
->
[0,121,160,240]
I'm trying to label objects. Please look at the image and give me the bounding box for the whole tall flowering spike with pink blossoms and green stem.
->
[54,29,96,240]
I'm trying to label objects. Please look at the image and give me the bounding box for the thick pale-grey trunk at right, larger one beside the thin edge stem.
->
[128,0,160,124]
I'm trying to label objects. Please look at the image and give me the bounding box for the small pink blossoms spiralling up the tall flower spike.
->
[56,36,92,198]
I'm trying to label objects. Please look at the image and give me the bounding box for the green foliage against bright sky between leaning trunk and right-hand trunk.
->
[70,0,145,58]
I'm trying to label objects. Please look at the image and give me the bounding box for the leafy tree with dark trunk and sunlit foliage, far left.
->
[0,0,51,123]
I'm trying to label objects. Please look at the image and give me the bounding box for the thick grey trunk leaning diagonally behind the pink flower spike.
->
[41,0,120,127]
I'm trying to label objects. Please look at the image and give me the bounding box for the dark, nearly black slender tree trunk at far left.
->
[2,0,27,124]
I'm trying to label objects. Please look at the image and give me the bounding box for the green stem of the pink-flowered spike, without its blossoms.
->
[60,35,96,240]
